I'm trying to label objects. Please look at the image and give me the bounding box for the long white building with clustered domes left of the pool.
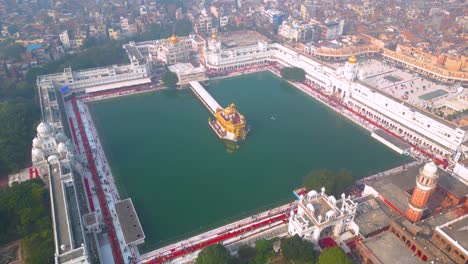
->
[31,122,92,263]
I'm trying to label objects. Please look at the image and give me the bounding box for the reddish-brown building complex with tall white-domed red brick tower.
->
[355,162,468,263]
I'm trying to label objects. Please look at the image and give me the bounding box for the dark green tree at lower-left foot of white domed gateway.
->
[281,235,317,263]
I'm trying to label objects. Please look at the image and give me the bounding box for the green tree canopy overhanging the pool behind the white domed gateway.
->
[303,169,354,195]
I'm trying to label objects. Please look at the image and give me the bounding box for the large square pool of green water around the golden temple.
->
[90,72,407,251]
